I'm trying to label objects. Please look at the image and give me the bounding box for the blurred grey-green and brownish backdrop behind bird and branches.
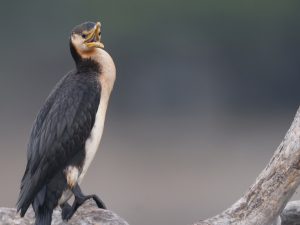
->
[0,0,300,225]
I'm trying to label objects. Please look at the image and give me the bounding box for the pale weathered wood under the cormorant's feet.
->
[0,201,128,225]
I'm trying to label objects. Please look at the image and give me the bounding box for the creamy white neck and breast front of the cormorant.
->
[58,49,116,205]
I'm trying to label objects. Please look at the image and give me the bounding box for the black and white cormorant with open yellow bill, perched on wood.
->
[17,21,116,225]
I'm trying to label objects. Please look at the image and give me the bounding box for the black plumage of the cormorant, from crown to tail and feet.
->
[17,22,110,225]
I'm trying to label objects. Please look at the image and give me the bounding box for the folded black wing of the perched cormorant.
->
[17,73,101,216]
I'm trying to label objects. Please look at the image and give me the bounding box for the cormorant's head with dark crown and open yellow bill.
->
[70,22,104,60]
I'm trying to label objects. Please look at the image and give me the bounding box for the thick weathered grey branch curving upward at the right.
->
[195,108,300,225]
